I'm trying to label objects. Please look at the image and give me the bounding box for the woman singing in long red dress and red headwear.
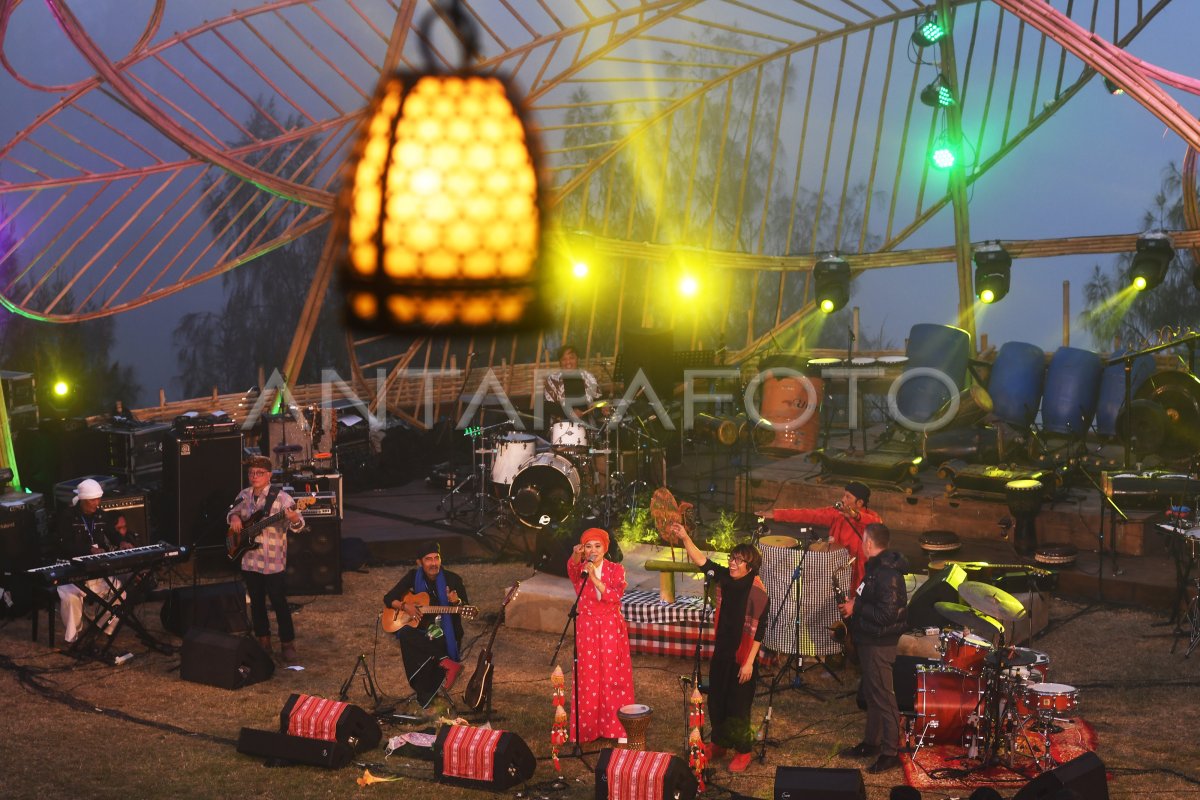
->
[566,528,634,742]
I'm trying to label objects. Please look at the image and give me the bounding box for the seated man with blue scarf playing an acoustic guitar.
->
[383,541,468,708]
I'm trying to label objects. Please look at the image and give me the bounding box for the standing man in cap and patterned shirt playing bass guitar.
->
[226,456,305,663]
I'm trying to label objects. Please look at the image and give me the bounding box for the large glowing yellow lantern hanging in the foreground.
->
[335,2,541,332]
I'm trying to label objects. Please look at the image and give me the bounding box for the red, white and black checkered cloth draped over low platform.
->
[620,589,716,658]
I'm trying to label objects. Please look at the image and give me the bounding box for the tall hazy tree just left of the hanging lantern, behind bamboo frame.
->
[172,101,347,397]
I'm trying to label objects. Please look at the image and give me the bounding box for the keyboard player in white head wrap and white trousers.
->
[52,477,124,644]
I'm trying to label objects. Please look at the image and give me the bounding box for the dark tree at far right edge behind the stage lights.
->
[1081,162,1200,350]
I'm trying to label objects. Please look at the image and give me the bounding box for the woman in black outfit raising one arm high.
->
[670,523,770,772]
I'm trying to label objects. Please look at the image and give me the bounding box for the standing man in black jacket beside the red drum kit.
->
[839,523,908,774]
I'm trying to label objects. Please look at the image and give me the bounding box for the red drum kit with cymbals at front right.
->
[907,581,1079,771]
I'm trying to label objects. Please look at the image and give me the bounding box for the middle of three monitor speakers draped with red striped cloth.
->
[433,724,538,792]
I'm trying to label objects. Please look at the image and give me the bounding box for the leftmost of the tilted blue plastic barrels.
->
[896,323,971,422]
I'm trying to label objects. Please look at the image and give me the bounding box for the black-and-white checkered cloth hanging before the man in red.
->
[761,545,854,656]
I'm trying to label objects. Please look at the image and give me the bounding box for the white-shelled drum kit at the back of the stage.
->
[453,401,662,531]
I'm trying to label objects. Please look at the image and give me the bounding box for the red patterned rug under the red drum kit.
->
[901,720,1096,795]
